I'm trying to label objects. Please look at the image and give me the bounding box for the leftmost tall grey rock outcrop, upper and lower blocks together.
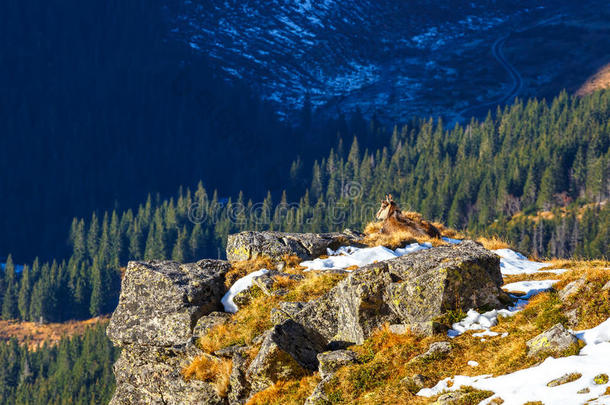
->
[107,260,230,405]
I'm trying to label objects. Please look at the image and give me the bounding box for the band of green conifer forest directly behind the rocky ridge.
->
[0,92,610,321]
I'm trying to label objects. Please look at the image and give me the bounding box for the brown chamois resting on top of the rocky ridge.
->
[376,194,441,238]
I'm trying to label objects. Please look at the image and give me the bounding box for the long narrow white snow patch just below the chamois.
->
[301,243,432,271]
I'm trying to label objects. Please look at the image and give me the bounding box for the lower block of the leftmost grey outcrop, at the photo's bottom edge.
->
[110,345,224,405]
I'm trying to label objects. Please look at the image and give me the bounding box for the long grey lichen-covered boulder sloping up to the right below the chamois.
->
[276,241,508,368]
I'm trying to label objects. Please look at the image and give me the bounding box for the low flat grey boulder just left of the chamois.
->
[227,231,362,262]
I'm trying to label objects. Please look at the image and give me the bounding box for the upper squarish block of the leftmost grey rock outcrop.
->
[107,260,230,346]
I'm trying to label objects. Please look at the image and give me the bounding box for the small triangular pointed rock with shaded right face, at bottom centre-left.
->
[246,329,304,395]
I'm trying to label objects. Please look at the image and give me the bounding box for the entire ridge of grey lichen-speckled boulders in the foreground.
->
[108,232,508,404]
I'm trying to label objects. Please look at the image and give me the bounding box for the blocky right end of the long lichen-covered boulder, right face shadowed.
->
[386,241,508,334]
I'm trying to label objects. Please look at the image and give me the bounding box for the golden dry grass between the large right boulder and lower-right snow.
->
[316,280,592,404]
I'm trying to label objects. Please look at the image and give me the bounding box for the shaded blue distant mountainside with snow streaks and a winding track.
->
[172,0,610,124]
